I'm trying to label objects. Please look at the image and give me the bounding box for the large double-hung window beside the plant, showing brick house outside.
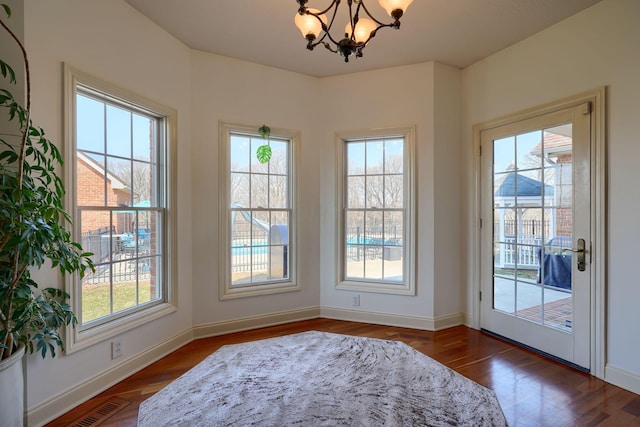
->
[66,65,174,350]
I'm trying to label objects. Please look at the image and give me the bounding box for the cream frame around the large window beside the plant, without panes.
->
[63,64,178,353]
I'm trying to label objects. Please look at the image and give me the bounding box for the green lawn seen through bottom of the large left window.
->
[82,280,151,323]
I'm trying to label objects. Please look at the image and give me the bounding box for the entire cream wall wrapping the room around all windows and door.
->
[16,0,640,423]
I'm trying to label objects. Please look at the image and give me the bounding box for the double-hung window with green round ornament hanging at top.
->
[220,123,299,299]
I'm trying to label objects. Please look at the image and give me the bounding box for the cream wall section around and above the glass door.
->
[463,0,640,392]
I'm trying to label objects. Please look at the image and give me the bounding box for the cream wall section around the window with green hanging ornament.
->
[190,51,322,333]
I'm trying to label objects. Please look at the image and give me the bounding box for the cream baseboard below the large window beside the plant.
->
[26,328,193,426]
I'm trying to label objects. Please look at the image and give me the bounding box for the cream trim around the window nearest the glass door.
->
[335,126,416,295]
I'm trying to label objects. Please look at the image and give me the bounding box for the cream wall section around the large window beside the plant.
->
[25,0,192,424]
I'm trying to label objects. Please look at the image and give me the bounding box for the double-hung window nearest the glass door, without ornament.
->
[337,128,415,294]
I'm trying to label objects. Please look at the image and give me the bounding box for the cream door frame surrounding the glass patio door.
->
[468,86,608,378]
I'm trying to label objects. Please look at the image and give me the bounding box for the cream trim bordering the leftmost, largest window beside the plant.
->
[63,64,178,353]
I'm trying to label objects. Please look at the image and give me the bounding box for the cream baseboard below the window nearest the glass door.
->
[320,307,465,331]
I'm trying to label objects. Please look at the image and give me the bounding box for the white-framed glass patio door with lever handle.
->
[481,106,590,369]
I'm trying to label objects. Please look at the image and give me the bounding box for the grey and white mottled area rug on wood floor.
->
[138,331,507,427]
